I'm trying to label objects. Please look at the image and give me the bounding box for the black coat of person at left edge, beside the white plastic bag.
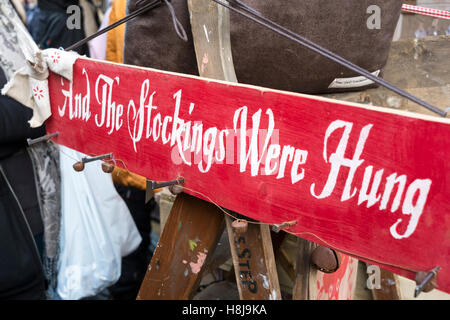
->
[0,70,45,300]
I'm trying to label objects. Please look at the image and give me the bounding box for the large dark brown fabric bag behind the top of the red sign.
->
[125,0,402,93]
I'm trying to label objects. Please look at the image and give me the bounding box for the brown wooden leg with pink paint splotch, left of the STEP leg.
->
[137,193,224,300]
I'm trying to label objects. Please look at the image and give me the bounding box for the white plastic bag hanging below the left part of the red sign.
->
[57,146,142,300]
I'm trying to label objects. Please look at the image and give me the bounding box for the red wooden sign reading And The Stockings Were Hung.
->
[47,59,450,292]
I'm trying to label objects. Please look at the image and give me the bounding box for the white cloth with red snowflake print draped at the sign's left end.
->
[0,0,79,128]
